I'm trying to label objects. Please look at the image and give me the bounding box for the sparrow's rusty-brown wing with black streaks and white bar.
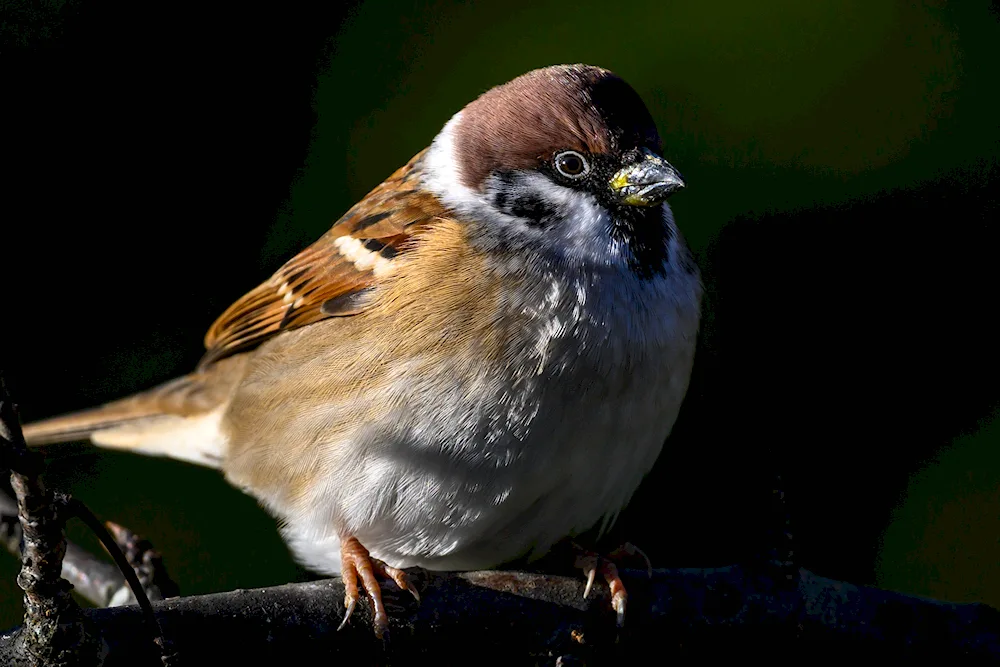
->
[199,152,444,368]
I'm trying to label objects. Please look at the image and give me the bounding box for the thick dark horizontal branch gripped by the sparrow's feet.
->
[0,566,1000,666]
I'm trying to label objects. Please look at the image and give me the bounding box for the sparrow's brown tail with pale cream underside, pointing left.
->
[24,355,246,468]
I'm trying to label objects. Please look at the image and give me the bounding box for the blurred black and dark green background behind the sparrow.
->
[0,0,1000,627]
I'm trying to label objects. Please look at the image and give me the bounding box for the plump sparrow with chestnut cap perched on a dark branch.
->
[24,65,702,636]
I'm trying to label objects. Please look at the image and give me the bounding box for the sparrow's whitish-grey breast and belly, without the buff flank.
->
[285,243,701,572]
